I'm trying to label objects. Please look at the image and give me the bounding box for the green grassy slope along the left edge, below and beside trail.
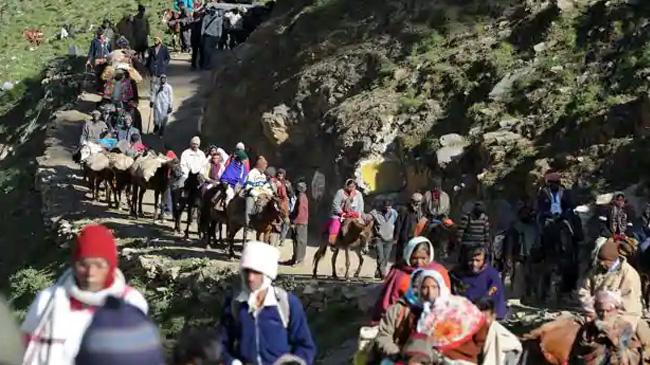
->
[0,0,167,309]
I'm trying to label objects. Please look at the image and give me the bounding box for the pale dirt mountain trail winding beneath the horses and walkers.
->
[45,54,376,279]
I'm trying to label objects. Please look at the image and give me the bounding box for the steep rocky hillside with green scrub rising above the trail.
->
[203,0,650,212]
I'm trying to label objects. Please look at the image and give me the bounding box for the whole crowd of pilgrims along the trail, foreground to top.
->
[5,0,650,365]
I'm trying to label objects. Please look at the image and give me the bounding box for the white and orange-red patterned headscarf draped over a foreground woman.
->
[417,270,485,353]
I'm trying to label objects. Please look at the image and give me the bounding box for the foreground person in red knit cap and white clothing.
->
[22,224,148,365]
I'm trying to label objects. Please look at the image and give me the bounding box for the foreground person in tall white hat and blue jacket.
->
[218,241,316,365]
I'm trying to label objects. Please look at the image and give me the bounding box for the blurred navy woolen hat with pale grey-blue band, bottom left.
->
[75,297,165,365]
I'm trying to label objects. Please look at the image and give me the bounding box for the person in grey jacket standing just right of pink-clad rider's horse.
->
[370,199,397,279]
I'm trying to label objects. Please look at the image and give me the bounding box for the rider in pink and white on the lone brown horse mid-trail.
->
[327,179,364,247]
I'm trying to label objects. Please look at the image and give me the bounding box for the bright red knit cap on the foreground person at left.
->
[72,224,117,287]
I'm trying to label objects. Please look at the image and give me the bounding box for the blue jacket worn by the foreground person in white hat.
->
[219,293,316,365]
